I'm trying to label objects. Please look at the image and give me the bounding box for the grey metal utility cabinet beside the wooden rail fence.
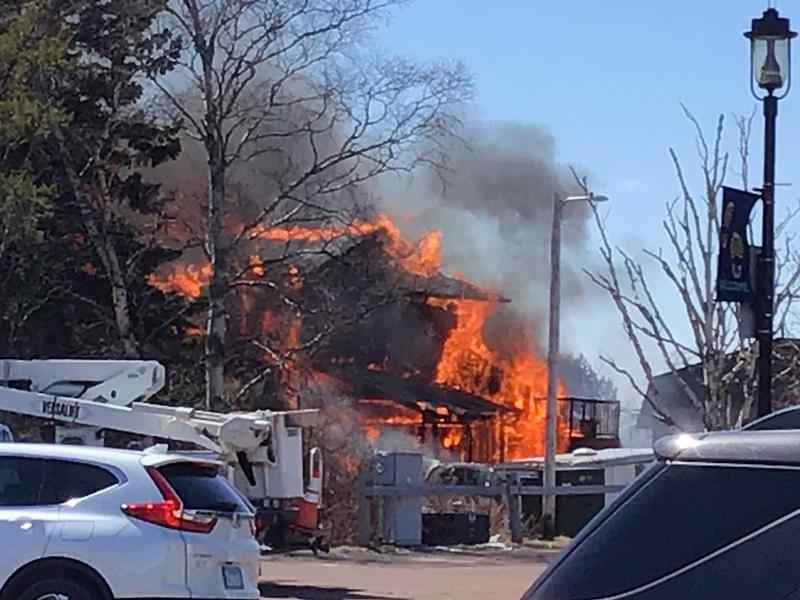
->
[374,452,422,546]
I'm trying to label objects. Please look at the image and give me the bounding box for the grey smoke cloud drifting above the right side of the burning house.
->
[382,124,591,356]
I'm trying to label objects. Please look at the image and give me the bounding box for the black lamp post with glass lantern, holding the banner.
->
[744,8,797,417]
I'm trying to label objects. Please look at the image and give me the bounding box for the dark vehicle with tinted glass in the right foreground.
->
[523,427,800,600]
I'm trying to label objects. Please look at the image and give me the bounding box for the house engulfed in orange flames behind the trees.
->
[151,216,612,462]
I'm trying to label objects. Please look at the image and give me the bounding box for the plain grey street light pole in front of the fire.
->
[542,194,564,538]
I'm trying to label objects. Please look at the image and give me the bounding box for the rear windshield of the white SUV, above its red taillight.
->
[158,463,250,512]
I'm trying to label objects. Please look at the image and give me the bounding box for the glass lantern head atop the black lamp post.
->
[744,8,797,100]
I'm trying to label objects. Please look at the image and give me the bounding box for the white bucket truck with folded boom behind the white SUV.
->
[0,360,322,552]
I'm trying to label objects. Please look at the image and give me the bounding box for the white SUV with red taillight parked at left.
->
[0,444,259,600]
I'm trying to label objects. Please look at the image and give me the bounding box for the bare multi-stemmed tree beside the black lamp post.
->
[584,106,800,429]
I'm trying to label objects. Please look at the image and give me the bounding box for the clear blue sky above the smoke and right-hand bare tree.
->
[381,0,800,408]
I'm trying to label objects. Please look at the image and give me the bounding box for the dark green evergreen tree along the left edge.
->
[0,0,203,394]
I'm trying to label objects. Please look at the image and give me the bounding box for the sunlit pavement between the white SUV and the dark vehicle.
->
[261,553,548,600]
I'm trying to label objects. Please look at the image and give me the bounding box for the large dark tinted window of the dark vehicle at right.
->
[535,465,800,598]
